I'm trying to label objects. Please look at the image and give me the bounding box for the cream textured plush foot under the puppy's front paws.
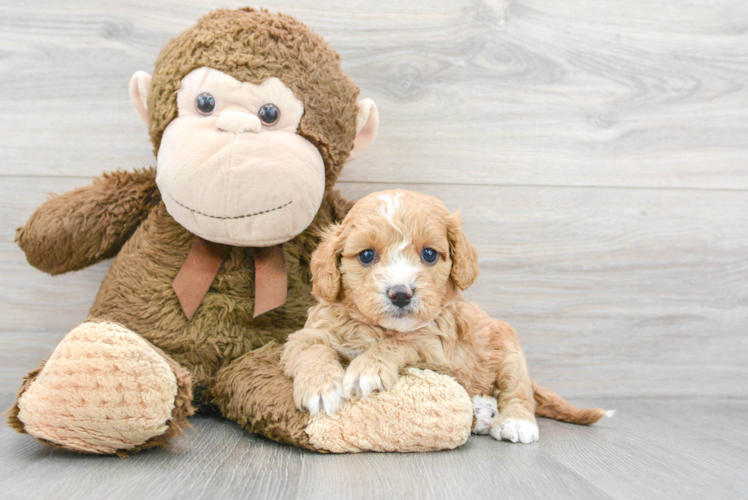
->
[306,368,473,453]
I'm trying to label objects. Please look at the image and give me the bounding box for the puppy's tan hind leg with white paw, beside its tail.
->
[491,321,540,443]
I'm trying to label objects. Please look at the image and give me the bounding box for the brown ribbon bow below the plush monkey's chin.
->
[171,238,288,320]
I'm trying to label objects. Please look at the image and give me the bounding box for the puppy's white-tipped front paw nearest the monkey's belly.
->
[293,365,345,415]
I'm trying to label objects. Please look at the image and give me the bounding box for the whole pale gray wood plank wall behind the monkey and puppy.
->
[0,0,748,399]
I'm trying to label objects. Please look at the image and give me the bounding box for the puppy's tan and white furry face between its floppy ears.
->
[341,191,453,332]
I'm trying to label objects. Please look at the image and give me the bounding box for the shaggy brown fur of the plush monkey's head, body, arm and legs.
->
[9,8,358,454]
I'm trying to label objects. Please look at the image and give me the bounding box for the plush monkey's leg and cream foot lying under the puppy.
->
[211,342,473,453]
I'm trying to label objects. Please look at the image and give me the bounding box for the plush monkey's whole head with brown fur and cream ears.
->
[130,8,378,246]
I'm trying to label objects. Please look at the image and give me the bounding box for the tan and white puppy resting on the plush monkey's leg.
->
[281,190,606,443]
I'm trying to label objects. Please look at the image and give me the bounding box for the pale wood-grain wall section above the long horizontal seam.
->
[0,0,748,189]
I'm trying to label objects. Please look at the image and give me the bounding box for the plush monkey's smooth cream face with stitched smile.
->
[156,68,325,247]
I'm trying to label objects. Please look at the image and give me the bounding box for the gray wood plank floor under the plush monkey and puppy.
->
[0,397,748,500]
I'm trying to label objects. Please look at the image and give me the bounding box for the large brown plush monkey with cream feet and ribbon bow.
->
[9,9,473,454]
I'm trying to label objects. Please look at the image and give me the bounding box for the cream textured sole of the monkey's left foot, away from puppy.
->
[18,323,177,453]
